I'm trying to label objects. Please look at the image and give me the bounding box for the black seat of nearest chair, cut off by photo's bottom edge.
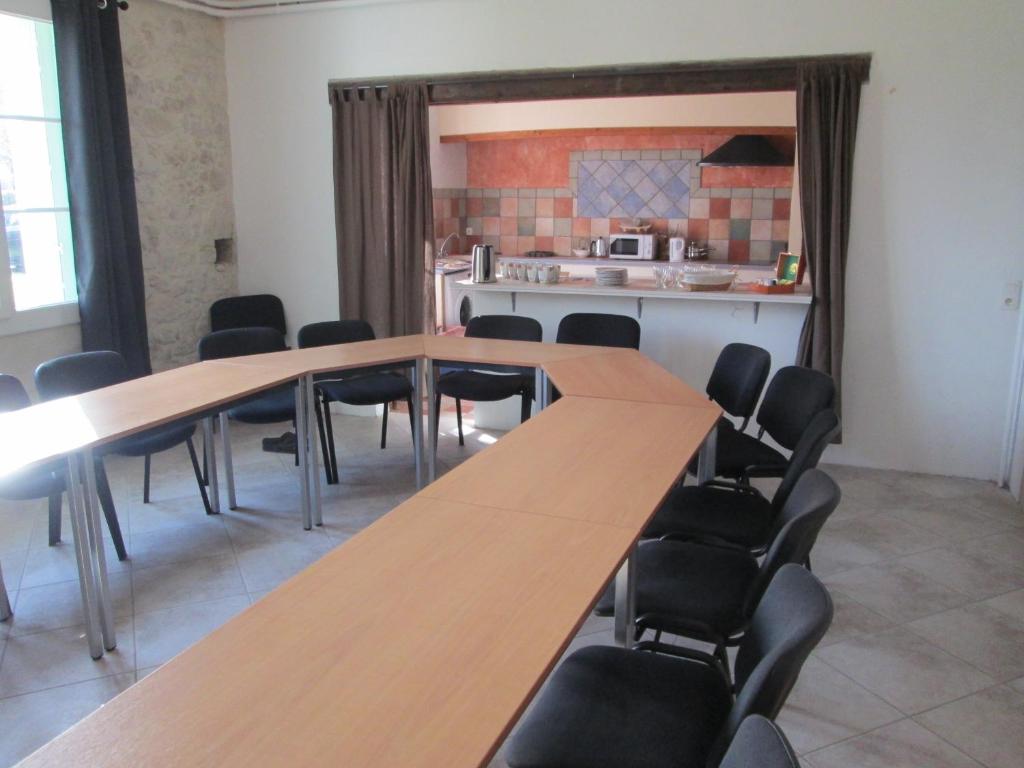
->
[507,646,732,768]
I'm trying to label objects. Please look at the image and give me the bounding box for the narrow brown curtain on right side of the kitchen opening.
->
[797,63,864,428]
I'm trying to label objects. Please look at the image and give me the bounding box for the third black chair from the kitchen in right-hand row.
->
[643,410,840,554]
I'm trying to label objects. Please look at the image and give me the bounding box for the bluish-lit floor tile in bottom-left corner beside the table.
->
[0,673,135,765]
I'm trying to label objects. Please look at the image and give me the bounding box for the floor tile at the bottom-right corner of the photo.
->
[915,686,1024,768]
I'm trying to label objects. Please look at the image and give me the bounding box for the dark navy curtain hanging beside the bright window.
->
[51,0,152,376]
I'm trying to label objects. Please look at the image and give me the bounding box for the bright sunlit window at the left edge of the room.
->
[0,5,77,317]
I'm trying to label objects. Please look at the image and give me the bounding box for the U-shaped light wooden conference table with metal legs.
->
[0,336,721,768]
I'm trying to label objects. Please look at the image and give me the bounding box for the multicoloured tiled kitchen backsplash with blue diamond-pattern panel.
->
[433,150,792,264]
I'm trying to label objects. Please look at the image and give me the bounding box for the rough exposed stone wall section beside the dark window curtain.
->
[120,0,238,370]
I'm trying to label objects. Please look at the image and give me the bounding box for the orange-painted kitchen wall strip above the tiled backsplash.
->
[466,133,793,188]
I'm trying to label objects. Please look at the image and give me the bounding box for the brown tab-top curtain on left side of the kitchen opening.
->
[331,83,434,337]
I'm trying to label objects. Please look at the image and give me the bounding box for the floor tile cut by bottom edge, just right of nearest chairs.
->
[802,720,979,768]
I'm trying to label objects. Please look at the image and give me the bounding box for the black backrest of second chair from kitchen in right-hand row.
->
[758,366,836,451]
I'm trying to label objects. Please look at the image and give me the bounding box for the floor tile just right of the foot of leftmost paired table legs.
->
[132,555,246,613]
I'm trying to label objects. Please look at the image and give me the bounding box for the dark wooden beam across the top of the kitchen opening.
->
[328,53,871,104]
